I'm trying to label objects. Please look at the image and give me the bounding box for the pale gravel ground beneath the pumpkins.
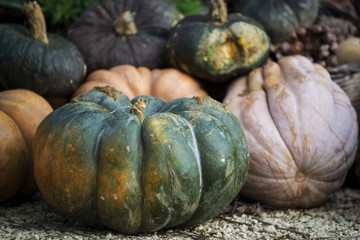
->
[0,188,360,240]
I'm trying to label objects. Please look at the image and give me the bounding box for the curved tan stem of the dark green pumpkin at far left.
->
[22,1,49,44]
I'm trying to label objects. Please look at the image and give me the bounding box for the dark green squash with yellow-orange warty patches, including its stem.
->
[166,0,270,82]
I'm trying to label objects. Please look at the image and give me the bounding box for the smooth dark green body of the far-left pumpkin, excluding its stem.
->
[0,24,86,97]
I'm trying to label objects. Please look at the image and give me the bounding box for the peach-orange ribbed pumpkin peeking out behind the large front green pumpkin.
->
[73,65,207,101]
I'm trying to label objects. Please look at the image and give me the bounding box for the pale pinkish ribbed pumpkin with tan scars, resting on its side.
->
[224,56,358,208]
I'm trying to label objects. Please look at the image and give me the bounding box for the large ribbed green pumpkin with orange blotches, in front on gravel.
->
[34,87,248,233]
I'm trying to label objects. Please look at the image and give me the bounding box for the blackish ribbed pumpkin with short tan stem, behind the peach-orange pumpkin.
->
[68,0,180,73]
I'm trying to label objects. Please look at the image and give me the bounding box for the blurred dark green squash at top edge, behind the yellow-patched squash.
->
[232,0,319,43]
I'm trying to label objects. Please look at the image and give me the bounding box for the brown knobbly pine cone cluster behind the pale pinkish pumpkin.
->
[271,15,357,67]
